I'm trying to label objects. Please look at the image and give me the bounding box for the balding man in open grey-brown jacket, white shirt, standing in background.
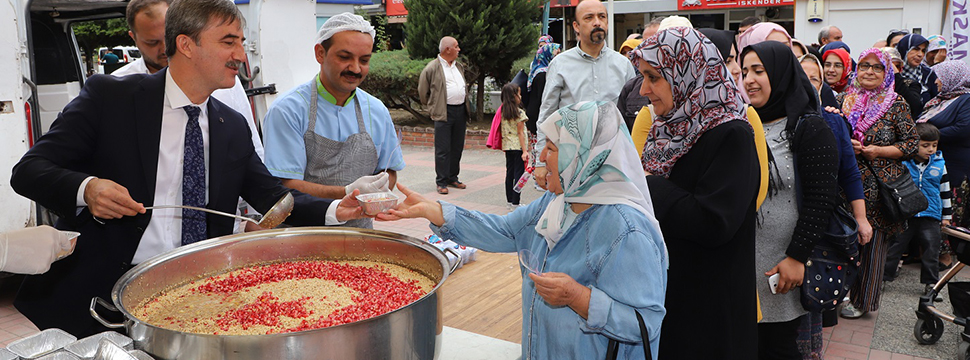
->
[418,36,468,194]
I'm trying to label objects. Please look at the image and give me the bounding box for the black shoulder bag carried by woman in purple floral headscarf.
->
[864,161,930,222]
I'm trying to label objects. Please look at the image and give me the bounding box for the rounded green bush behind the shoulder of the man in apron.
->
[360,50,431,121]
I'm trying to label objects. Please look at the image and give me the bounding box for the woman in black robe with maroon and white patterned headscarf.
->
[631,27,760,359]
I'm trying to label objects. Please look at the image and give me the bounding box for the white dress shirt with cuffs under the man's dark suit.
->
[77,71,341,264]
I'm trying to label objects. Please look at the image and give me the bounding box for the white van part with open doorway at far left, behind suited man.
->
[0,0,128,232]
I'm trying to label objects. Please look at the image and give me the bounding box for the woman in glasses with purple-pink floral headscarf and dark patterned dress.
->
[836,47,919,319]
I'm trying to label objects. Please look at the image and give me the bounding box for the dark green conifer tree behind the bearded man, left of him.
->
[404,0,542,119]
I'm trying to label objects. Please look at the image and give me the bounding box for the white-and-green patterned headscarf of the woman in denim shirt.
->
[536,101,660,249]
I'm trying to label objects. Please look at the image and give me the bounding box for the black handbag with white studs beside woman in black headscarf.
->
[801,206,862,312]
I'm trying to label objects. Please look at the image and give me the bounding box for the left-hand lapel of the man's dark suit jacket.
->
[133,69,167,206]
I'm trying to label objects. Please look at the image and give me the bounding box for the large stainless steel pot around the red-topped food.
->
[91,227,460,360]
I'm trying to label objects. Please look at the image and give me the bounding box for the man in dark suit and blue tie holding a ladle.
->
[11,0,362,337]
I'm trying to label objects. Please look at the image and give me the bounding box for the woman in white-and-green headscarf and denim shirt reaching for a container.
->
[379,102,667,359]
